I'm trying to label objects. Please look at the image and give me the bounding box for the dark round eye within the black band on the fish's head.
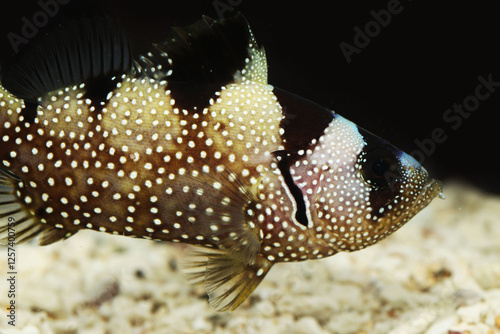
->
[360,147,401,188]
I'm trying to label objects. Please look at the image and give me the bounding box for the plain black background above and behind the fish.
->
[0,0,500,193]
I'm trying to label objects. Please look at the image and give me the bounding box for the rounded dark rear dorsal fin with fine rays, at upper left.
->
[2,17,133,102]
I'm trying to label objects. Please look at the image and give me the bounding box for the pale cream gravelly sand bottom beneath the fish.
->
[0,183,500,334]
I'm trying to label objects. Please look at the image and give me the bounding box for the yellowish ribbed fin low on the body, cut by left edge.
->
[0,167,73,246]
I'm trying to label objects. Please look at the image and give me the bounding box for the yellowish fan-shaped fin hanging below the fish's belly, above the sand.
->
[183,247,273,312]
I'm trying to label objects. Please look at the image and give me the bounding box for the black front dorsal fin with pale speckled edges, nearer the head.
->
[136,13,267,85]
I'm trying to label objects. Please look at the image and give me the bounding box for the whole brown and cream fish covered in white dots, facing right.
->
[0,14,444,311]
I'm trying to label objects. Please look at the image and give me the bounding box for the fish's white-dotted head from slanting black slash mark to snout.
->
[291,114,444,252]
